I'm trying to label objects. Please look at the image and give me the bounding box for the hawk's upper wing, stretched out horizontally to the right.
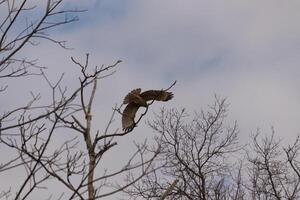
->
[140,90,173,101]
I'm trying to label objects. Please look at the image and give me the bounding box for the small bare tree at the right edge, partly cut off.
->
[247,129,300,199]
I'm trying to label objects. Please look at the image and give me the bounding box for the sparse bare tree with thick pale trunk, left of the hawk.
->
[1,54,162,199]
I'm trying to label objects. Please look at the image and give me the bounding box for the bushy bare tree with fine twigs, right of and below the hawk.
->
[126,97,241,199]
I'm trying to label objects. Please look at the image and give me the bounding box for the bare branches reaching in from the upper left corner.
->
[0,0,83,83]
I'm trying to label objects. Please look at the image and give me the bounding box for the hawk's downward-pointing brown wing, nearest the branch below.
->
[122,103,140,131]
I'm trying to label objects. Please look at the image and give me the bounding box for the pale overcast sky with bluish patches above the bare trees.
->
[1,0,300,198]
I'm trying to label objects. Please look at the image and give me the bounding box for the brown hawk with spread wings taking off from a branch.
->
[122,88,173,131]
